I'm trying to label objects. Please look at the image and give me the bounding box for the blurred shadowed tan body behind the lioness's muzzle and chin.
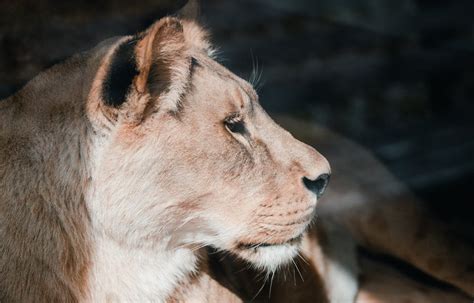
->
[178,117,474,303]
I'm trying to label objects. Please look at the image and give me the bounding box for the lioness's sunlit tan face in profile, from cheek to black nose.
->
[87,19,330,270]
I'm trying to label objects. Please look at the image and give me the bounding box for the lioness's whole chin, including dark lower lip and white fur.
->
[232,238,301,272]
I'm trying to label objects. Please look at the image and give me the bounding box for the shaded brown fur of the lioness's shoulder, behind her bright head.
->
[0,47,108,302]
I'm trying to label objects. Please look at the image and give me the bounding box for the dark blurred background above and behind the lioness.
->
[0,0,474,240]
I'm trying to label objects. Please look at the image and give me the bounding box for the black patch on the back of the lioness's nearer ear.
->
[102,38,138,107]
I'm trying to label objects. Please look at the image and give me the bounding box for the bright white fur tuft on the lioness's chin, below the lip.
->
[246,244,299,272]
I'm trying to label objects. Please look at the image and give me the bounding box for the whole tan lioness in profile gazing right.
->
[0,2,472,302]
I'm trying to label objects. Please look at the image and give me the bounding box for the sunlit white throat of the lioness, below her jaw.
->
[89,236,197,302]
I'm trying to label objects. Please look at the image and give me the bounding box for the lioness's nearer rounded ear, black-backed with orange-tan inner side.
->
[102,17,188,108]
